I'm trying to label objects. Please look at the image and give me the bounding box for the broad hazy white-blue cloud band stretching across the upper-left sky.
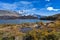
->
[0,1,33,10]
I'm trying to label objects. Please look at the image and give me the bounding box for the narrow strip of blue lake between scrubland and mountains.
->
[0,19,49,24]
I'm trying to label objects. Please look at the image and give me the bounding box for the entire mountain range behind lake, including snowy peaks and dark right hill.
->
[0,10,60,20]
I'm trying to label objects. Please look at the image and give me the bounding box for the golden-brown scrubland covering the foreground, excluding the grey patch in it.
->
[0,20,60,40]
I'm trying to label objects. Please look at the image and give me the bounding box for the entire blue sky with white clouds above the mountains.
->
[0,0,60,16]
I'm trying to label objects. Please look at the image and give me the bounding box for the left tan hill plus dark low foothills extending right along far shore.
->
[0,10,38,19]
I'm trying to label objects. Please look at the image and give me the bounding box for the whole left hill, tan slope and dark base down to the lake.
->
[0,10,20,19]
